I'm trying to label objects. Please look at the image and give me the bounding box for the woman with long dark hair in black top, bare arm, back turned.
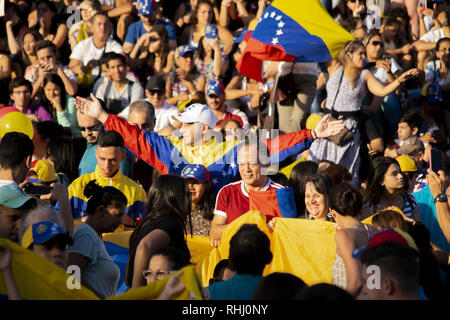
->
[125,174,192,288]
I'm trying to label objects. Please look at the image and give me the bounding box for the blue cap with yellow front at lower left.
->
[22,221,73,248]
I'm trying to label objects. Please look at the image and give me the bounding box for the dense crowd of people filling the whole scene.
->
[0,0,450,300]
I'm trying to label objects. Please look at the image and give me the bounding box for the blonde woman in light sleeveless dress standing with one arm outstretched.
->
[308,40,419,187]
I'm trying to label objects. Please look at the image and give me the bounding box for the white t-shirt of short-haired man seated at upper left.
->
[70,37,124,76]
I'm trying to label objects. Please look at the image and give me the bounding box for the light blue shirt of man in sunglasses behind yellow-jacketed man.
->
[78,143,134,179]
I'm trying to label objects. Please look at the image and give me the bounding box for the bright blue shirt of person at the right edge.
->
[413,186,450,253]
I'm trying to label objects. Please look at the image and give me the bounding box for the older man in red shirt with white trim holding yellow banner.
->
[209,141,284,247]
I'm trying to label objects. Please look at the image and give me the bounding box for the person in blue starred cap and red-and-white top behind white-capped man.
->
[205,80,250,134]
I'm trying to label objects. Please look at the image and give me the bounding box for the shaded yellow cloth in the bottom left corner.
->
[0,239,98,300]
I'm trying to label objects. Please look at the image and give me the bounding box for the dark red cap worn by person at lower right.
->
[352,228,418,259]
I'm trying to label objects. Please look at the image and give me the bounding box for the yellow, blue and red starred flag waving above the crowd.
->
[237,0,354,81]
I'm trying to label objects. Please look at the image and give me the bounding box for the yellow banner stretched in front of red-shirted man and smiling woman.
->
[97,211,336,286]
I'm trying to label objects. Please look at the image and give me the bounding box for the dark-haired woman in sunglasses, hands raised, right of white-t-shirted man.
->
[130,25,174,81]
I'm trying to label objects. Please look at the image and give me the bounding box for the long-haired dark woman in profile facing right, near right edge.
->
[364,157,419,219]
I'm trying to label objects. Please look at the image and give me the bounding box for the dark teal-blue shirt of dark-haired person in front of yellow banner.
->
[208,274,263,300]
